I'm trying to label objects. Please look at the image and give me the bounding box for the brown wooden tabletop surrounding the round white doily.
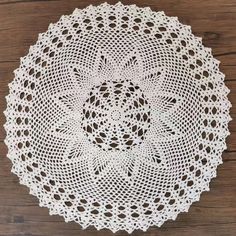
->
[0,0,236,236]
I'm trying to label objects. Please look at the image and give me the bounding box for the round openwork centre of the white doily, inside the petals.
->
[82,80,150,151]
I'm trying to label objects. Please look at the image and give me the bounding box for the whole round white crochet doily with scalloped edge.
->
[5,3,230,232]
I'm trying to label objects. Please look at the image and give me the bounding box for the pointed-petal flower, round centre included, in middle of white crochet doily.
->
[50,52,181,180]
